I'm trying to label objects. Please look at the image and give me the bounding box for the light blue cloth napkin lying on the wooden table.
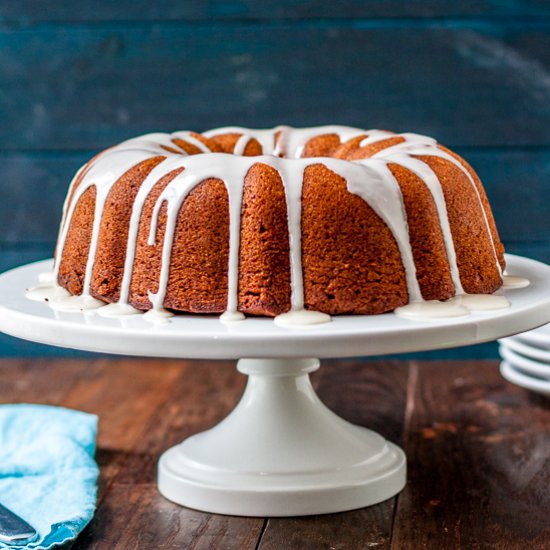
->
[0,404,99,550]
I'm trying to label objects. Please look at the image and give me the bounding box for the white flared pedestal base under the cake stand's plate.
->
[158,359,406,516]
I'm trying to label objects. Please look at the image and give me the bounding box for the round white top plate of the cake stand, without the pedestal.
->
[0,255,550,359]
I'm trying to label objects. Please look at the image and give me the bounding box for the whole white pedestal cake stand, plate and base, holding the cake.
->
[0,256,550,516]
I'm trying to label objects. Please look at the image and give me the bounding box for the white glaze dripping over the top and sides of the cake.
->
[52,126,512,322]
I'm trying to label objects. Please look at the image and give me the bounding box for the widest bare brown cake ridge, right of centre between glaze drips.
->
[302,164,408,315]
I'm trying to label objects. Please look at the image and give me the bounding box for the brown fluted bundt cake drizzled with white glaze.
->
[45,126,504,322]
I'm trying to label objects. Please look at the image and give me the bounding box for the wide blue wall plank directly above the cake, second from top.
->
[0,23,550,150]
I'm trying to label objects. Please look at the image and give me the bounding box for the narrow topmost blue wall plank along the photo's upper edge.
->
[0,0,550,24]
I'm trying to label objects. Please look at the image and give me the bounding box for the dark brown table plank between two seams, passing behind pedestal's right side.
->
[259,360,408,550]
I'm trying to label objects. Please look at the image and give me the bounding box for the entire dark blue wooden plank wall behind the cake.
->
[0,0,550,356]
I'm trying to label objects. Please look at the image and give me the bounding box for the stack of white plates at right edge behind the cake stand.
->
[499,324,550,395]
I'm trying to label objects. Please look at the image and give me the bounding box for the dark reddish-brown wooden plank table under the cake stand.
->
[0,358,550,550]
